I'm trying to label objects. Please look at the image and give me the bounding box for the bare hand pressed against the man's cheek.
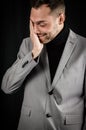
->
[30,20,43,59]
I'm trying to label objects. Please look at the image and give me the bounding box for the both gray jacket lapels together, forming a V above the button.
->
[40,30,77,92]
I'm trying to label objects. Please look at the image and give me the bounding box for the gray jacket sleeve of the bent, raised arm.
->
[1,40,38,94]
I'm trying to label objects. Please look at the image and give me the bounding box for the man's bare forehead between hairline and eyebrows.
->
[30,5,52,21]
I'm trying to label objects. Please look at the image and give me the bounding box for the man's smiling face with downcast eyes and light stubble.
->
[30,5,63,44]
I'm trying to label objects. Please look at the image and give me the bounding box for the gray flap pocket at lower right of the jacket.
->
[64,115,83,125]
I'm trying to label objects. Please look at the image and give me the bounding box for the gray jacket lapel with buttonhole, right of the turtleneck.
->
[52,30,77,87]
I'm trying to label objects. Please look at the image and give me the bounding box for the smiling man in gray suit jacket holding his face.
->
[1,0,86,130]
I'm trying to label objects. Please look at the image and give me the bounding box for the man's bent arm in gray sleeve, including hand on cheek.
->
[1,21,43,93]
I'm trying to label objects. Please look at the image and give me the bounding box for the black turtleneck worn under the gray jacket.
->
[46,25,69,82]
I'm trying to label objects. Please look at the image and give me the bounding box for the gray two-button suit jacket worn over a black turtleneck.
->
[1,30,86,130]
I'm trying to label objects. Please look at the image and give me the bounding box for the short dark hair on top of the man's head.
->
[31,0,65,11]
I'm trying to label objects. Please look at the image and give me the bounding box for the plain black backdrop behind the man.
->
[0,0,86,130]
